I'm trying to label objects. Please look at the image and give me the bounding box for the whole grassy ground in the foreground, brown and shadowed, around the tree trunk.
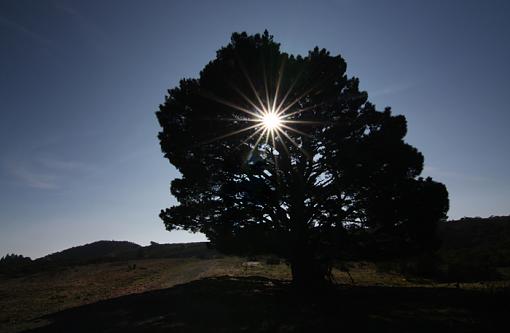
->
[0,257,510,332]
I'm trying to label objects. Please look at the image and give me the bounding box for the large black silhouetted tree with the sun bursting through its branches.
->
[156,31,448,284]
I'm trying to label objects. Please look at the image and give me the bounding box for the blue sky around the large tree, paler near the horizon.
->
[0,0,510,257]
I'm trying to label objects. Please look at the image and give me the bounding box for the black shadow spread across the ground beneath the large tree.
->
[22,277,510,332]
